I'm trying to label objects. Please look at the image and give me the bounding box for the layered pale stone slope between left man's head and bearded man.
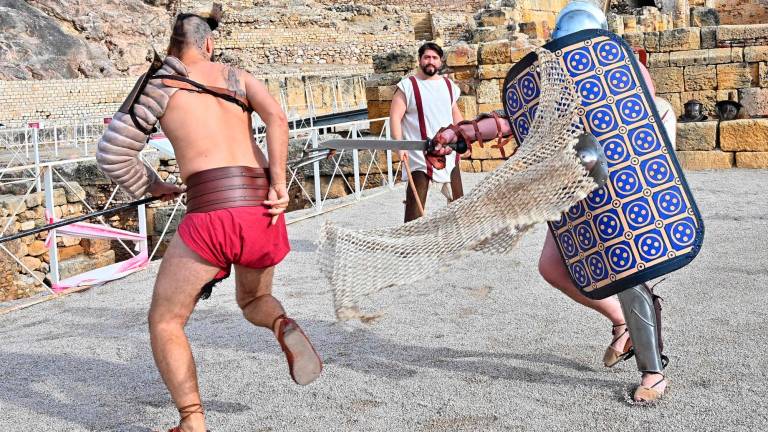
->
[167,0,424,73]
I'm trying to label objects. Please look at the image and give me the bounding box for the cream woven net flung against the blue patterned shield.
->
[318,49,596,320]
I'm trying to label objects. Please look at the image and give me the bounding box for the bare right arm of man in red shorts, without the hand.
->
[243,73,288,186]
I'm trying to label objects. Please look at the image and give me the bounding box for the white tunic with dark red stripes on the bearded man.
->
[397,77,461,183]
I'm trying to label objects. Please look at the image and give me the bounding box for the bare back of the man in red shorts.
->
[160,62,268,179]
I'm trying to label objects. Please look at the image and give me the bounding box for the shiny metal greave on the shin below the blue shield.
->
[618,284,666,373]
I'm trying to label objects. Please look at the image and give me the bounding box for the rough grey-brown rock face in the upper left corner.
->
[0,0,170,80]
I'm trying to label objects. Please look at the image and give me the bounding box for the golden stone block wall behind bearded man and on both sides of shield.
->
[366,25,768,172]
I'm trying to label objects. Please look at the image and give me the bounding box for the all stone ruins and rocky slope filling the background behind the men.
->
[0,0,768,301]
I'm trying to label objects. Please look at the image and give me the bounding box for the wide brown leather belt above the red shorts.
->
[186,166,269,213]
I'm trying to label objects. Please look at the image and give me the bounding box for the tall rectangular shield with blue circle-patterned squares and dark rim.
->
[502,30,704,299]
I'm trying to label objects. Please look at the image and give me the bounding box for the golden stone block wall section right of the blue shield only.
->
[624,24,768,169]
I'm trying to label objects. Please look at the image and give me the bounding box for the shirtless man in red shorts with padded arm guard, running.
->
[97,6,323,432]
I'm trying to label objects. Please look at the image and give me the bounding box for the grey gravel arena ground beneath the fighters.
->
[0,169,768,432]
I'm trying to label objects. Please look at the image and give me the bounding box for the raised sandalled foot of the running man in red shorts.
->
[272,314,323,385]
